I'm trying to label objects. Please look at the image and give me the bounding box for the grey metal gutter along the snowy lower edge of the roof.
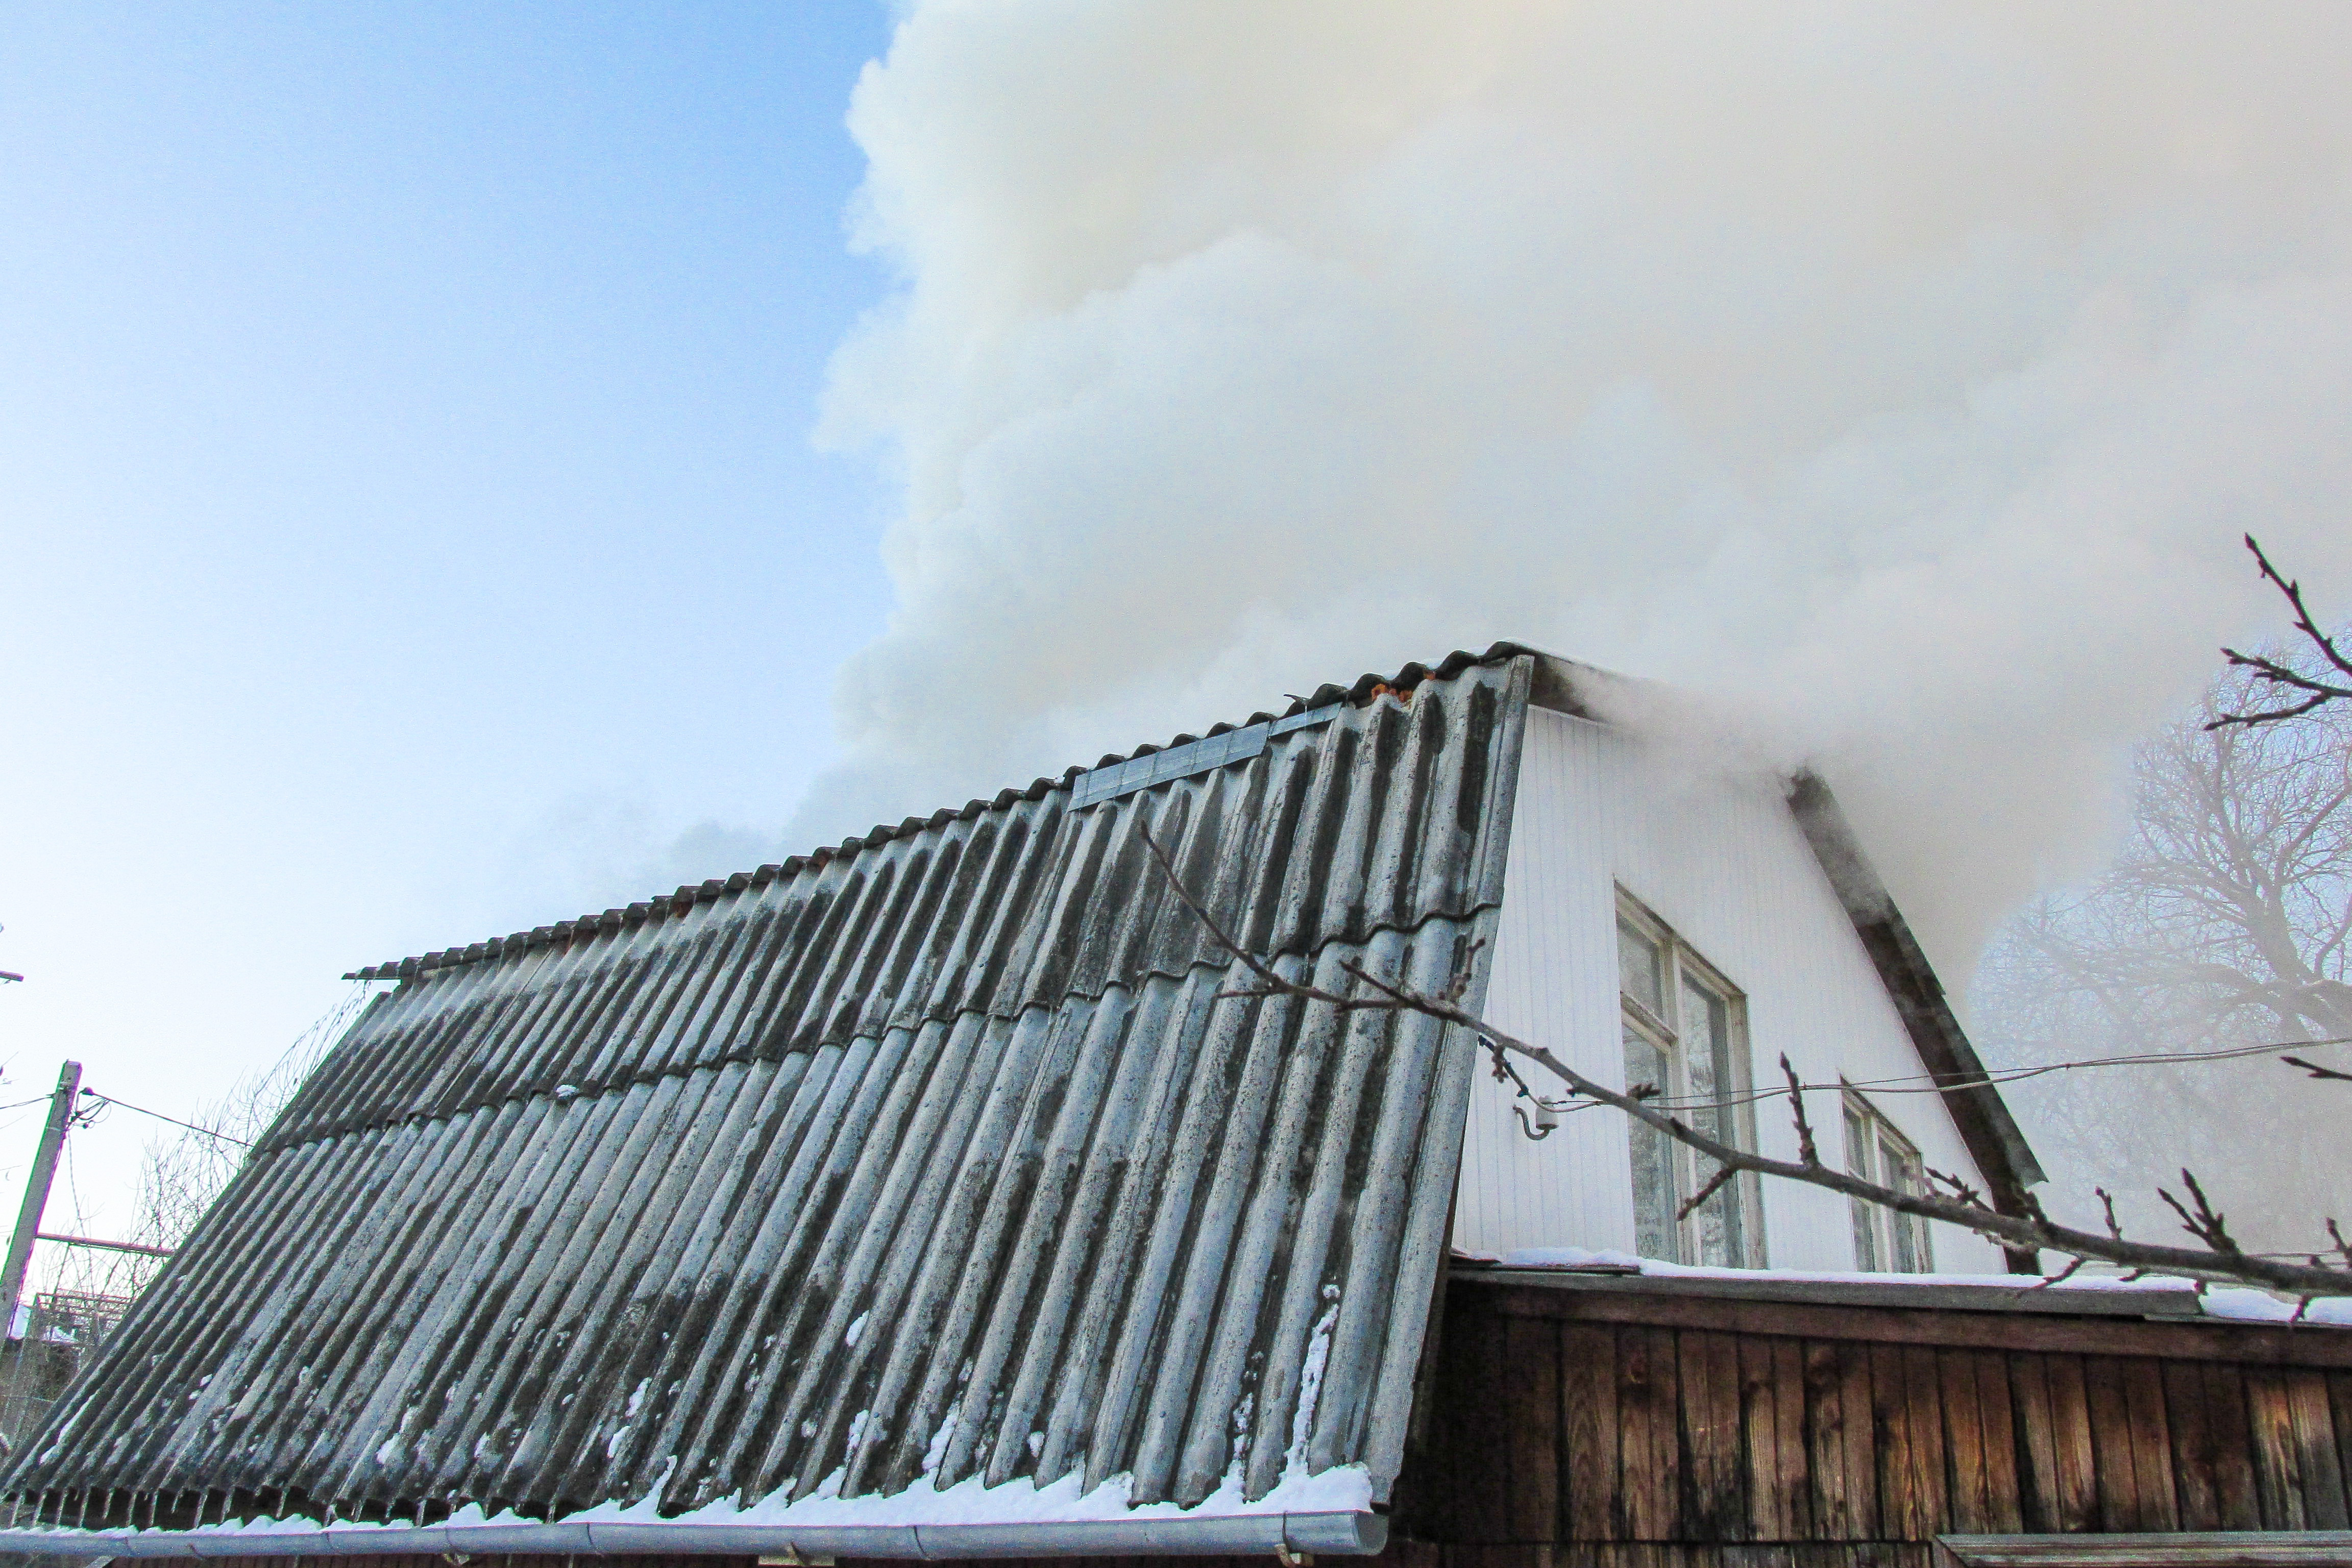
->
[0,1511,1388,1561]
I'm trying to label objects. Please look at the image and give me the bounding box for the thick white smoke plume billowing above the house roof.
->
[795,0,2352,969]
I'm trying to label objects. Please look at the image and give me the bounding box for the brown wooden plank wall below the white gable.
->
[1395,1284,2352,1542]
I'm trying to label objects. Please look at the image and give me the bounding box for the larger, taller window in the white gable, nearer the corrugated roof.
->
[1618,891,1764,1269]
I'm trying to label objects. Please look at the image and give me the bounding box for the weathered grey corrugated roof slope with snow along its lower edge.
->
[7,647,1533,1523]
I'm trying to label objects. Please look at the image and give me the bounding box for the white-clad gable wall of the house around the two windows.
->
[1454,707,2001,1272]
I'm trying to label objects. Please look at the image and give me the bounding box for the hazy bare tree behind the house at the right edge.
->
[1978,538,2352,1248]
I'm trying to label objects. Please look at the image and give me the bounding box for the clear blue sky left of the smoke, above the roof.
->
[0,0,889,1222]
